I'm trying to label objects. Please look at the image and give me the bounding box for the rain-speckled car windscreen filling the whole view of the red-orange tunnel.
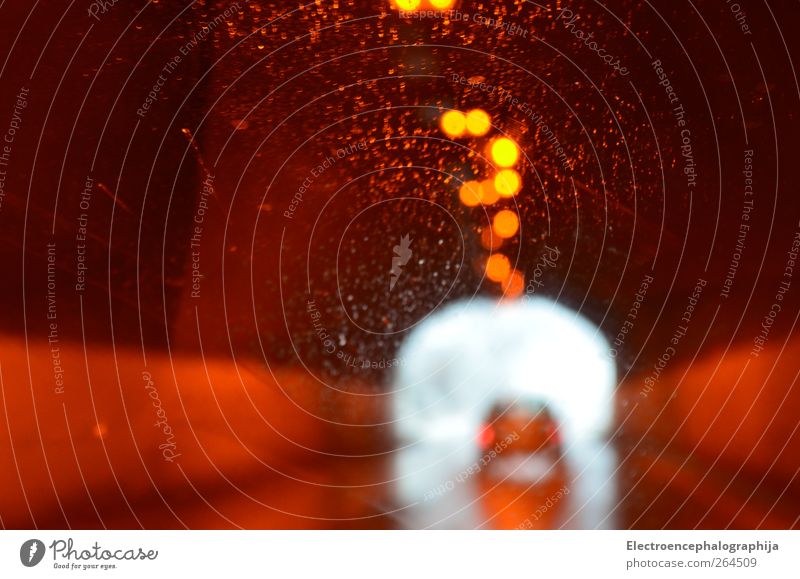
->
[0,0,800,529]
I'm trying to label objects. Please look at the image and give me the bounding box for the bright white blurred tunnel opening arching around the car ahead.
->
[393,298,616,527]
